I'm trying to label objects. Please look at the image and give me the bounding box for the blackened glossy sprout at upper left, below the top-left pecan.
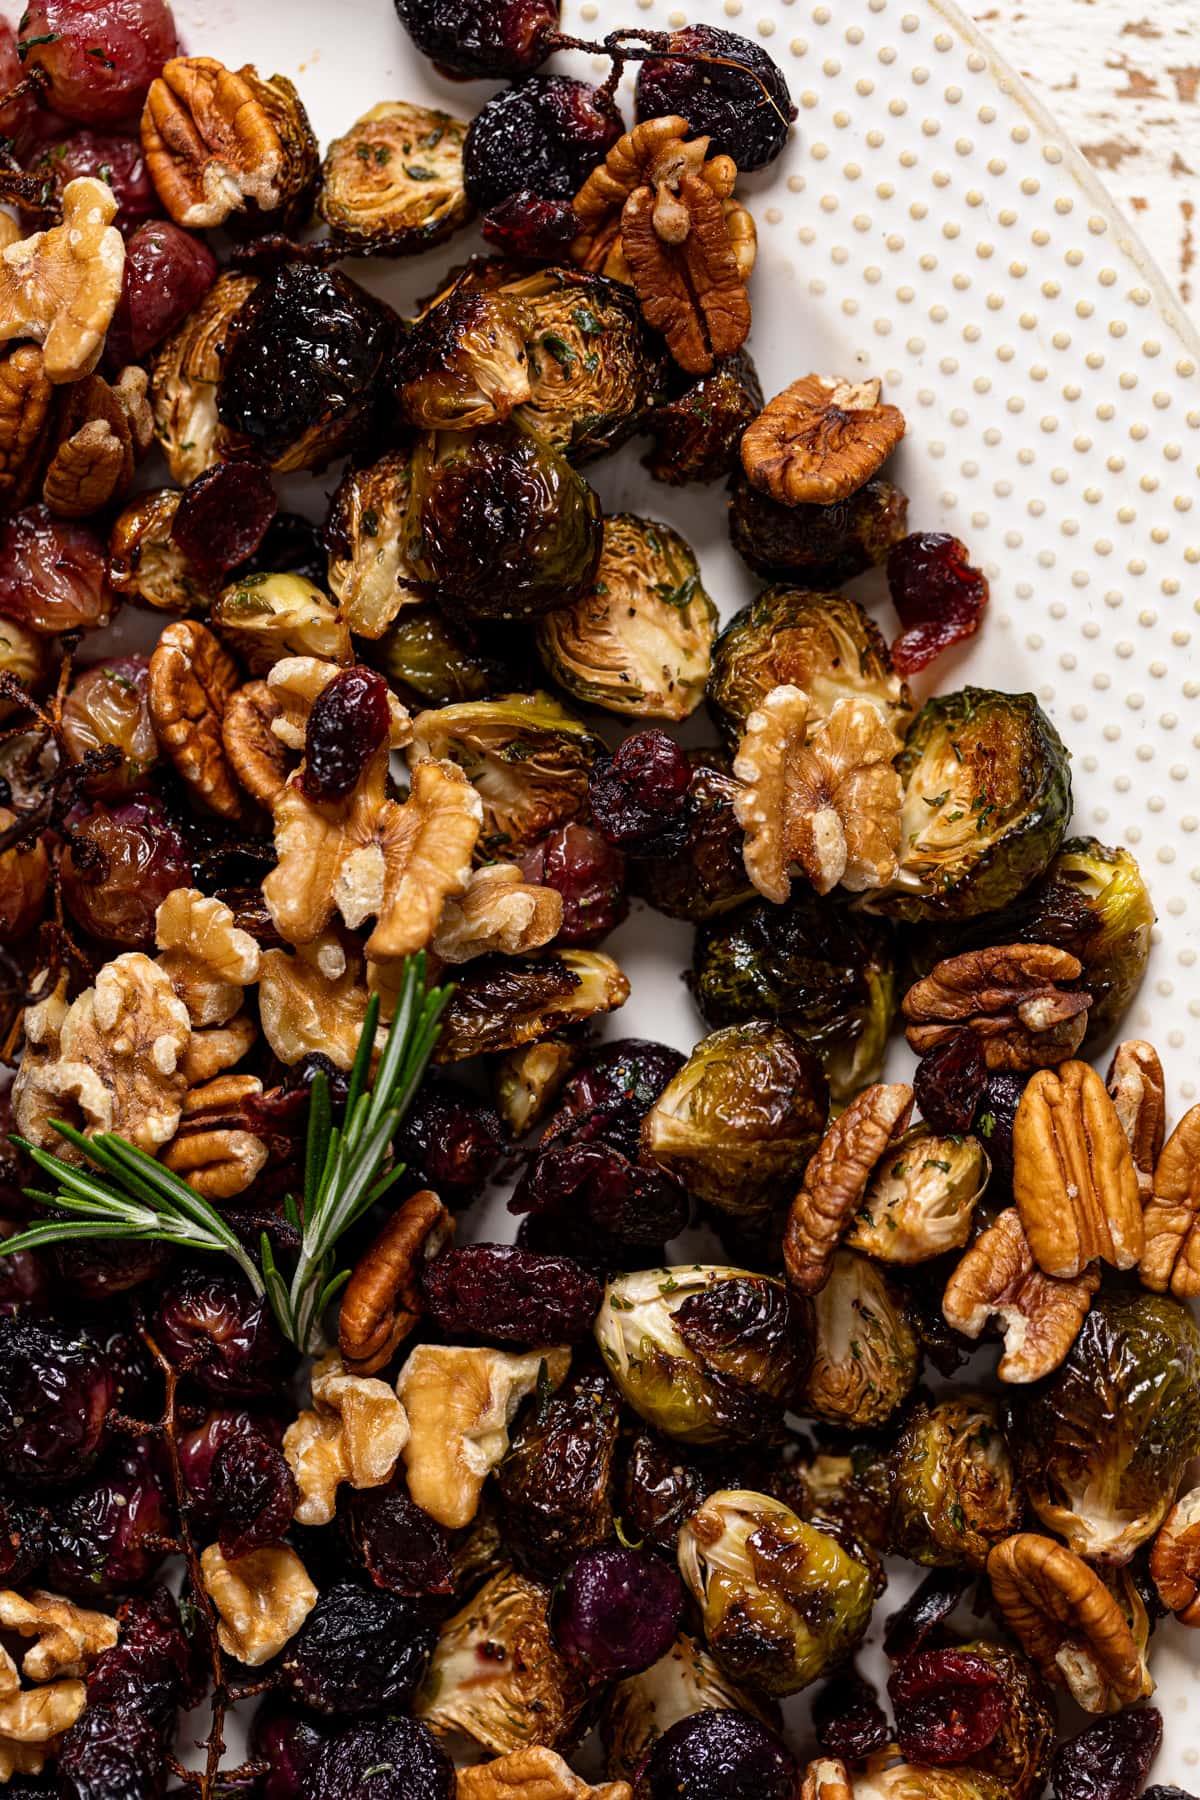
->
[218,263,396,470]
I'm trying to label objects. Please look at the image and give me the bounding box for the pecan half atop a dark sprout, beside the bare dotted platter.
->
[741,374,905,506]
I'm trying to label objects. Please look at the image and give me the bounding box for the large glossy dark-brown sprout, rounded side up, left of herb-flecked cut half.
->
[405,418,603,619]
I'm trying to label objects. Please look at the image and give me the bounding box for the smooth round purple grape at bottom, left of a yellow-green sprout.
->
[551,1548,684,1681]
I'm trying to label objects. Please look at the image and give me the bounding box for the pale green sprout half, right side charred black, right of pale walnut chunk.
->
[596,1264,808,1444]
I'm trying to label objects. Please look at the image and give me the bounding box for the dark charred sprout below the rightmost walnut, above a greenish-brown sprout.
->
[687,889,896,1100]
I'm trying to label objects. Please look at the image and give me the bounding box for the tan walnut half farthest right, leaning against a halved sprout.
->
[734,688,901,905]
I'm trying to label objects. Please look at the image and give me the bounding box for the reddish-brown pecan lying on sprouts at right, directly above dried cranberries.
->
[903,943,1092,1071]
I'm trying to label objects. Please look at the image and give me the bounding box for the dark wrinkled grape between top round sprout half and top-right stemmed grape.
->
[462,76,624,212]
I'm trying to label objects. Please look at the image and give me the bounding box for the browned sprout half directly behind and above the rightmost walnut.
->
[709,587,912,749]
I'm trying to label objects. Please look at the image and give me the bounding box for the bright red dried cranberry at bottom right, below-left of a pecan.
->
[887,1651,1009,1768]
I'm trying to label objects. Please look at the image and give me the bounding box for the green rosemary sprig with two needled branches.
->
[0,954,453,1352]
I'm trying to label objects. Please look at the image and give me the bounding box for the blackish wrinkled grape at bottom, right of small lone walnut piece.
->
[282,1580,437,1719]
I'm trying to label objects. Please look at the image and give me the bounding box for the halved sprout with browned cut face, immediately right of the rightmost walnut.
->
[860,688,1070,922]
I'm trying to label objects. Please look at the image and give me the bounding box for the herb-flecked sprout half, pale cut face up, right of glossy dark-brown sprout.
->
[536,513,716,724]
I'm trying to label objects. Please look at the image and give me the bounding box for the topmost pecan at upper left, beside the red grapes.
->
[142,56,317,230]
